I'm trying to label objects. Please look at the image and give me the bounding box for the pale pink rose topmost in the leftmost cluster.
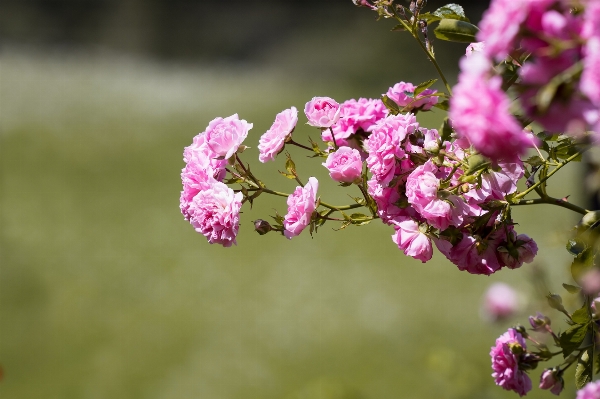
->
[206,114,253,159]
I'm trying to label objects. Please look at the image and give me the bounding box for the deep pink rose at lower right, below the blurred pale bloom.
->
[490,328,531,396]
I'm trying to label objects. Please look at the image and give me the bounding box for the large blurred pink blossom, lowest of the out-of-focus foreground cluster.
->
[449,53,534,161]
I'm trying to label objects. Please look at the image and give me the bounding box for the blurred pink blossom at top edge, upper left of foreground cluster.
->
[477,0,533,61]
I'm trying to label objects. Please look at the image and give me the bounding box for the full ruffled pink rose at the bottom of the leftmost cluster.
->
[188,182,243,247]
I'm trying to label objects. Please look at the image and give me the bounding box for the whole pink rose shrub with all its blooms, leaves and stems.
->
[180,0,600,398]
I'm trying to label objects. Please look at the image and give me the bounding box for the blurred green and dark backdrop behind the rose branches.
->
[0,0,583,399]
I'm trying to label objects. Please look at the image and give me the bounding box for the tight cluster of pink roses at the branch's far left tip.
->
[179,114,252,247]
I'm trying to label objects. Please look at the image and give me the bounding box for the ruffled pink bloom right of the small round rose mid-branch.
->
[364,114,419,185]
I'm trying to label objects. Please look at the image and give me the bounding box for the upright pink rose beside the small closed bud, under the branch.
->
[283,177,319,239]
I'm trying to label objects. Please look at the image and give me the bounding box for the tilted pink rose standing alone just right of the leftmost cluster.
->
[258,107,298,163]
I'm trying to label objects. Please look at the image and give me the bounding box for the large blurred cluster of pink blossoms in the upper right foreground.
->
[449,0,600,160]
